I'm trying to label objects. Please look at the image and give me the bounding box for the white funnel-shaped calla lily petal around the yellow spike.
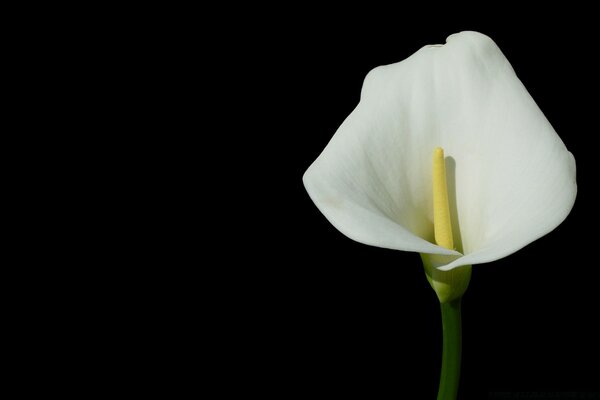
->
[304,32,577,270]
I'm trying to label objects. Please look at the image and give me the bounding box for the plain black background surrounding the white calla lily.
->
[14,7,600,399]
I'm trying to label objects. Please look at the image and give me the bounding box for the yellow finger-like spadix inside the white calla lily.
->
[432,147,454,250]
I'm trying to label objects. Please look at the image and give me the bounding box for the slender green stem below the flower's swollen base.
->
[437,297,462,400]
